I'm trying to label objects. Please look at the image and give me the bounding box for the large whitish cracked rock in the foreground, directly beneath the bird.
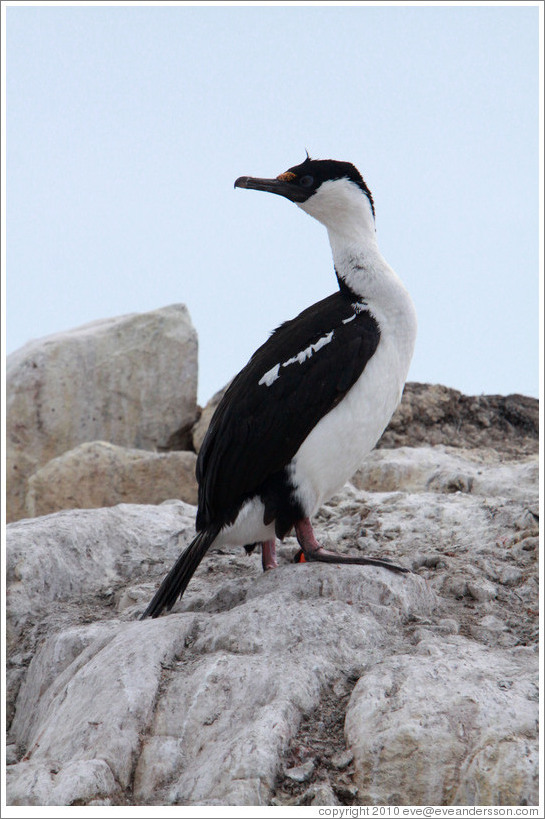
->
[7,566,434,804]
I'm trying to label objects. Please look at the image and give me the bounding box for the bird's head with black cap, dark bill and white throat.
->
[235,154,375,240]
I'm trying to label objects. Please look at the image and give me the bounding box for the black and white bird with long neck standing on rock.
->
[143,155,416,618]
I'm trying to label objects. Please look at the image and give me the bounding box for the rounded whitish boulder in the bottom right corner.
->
[346,637,539,805]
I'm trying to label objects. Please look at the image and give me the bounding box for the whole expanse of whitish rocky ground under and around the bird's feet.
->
[7,448,539,806]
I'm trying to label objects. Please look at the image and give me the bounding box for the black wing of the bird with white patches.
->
[197,292,380,530]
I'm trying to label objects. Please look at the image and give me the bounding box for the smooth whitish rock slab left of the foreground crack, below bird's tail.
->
[7,618,193,804]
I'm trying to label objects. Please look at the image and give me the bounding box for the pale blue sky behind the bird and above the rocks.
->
[7,4,539,403]
